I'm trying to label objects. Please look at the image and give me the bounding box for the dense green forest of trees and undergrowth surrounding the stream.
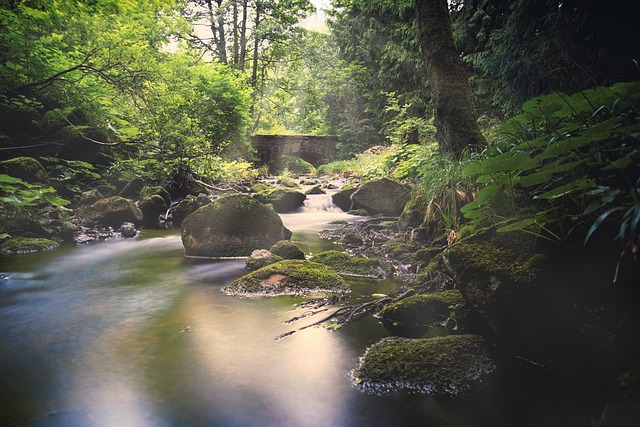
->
[0,0,640,426]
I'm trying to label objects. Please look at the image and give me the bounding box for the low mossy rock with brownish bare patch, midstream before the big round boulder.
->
[222,260,349,297]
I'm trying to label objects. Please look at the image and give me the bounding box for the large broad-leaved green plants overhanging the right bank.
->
[463,83,640,246]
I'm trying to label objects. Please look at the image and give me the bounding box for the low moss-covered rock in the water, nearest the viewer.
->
[353,335,496,397]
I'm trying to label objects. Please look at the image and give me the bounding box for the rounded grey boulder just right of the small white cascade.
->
[350,178,409,216]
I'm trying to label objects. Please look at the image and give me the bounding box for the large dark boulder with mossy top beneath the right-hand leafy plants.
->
[444,229,640,380]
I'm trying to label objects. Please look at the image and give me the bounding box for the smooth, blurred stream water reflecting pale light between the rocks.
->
[0,187,596,427]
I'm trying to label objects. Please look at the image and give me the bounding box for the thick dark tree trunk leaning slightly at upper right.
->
[416,0,486,158]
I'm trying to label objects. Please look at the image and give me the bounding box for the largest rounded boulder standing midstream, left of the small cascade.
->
[182,194,291,257]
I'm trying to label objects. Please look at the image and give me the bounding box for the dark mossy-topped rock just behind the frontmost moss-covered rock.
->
[378,289,462,326]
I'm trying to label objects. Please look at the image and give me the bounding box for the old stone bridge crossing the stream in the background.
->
[251,135,338,170]
